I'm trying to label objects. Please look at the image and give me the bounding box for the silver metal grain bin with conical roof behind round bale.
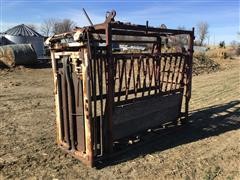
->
[0,24,44,57]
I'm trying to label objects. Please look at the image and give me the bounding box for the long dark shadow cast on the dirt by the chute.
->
[97,101,240,168]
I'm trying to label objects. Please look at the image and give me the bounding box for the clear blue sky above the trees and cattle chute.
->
[0,0,240,44]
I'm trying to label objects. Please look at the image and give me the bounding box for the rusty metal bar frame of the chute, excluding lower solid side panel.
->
[49,11,194,167]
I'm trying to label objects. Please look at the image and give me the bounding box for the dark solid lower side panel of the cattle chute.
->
[113,93,182,140]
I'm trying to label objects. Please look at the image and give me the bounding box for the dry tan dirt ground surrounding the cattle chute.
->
[0,59,240,180]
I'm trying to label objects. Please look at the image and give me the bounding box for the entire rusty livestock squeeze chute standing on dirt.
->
[49,11,194,167]
